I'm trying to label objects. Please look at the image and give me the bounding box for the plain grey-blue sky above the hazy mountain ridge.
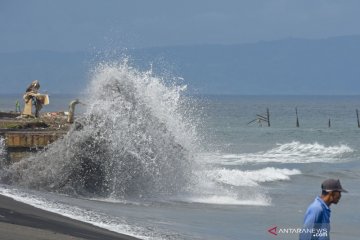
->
[0,0,360,52]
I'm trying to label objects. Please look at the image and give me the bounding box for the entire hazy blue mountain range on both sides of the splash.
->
[0,36,360,95]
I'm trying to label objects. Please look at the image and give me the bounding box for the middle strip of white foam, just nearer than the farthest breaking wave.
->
[207,167,301,186]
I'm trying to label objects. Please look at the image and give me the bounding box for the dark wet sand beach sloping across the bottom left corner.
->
[0,195,140,240]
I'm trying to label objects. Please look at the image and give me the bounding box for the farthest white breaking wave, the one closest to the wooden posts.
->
[218,141,354,165]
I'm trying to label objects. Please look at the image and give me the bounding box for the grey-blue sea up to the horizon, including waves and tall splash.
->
[0,62,360,240]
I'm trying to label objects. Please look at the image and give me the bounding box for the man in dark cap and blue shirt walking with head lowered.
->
[299,179,347,240]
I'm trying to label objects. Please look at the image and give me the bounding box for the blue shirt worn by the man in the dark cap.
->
[299,197,331,240]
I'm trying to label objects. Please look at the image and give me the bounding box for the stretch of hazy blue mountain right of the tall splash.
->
[129,36,360,94]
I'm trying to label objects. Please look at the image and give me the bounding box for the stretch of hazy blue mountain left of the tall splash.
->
[0,51,88,93]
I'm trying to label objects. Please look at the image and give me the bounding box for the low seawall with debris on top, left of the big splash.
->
[0,112,70,163]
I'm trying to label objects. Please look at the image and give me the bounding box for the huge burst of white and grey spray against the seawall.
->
[3,61,197,197]
